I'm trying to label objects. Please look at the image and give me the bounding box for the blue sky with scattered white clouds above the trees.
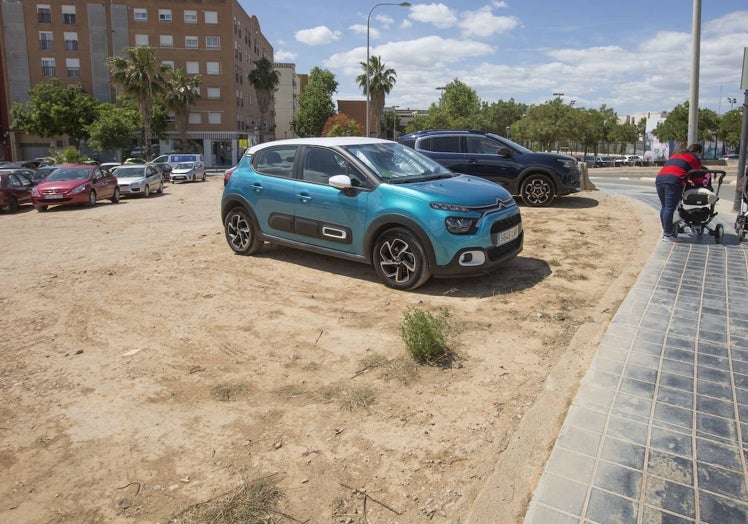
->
[240,0,748,115]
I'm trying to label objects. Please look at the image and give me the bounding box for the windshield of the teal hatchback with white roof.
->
[343,143,454,182]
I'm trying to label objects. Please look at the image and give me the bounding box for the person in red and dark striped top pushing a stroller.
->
[655,144,704,242]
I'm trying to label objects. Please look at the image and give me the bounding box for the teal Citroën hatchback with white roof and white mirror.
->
[221,137,524,290]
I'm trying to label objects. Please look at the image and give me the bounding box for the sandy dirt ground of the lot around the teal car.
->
[0,177,658,523]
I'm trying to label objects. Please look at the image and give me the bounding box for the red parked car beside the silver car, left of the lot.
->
[31,164,119,211]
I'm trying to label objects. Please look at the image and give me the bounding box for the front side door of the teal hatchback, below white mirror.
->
[294,147,370,255]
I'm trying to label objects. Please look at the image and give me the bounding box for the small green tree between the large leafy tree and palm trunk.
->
[87,104,142,151]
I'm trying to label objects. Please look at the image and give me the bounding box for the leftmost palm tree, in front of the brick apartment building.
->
[107,47,171,160]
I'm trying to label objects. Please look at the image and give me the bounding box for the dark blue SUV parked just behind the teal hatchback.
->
[398,129,581,207]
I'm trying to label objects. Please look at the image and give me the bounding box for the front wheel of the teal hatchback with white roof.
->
[372,227,431,290]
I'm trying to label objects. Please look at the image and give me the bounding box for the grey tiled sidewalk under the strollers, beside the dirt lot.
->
[525,191,748,524]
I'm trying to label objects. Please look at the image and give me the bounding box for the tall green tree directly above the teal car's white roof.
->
[291,67,338,137]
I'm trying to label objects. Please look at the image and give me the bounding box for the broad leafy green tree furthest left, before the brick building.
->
[10,78,99,148]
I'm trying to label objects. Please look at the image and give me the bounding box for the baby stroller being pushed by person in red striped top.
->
[673,169,726,244]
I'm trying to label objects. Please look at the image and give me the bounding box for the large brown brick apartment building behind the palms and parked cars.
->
[0,0,275,166]
